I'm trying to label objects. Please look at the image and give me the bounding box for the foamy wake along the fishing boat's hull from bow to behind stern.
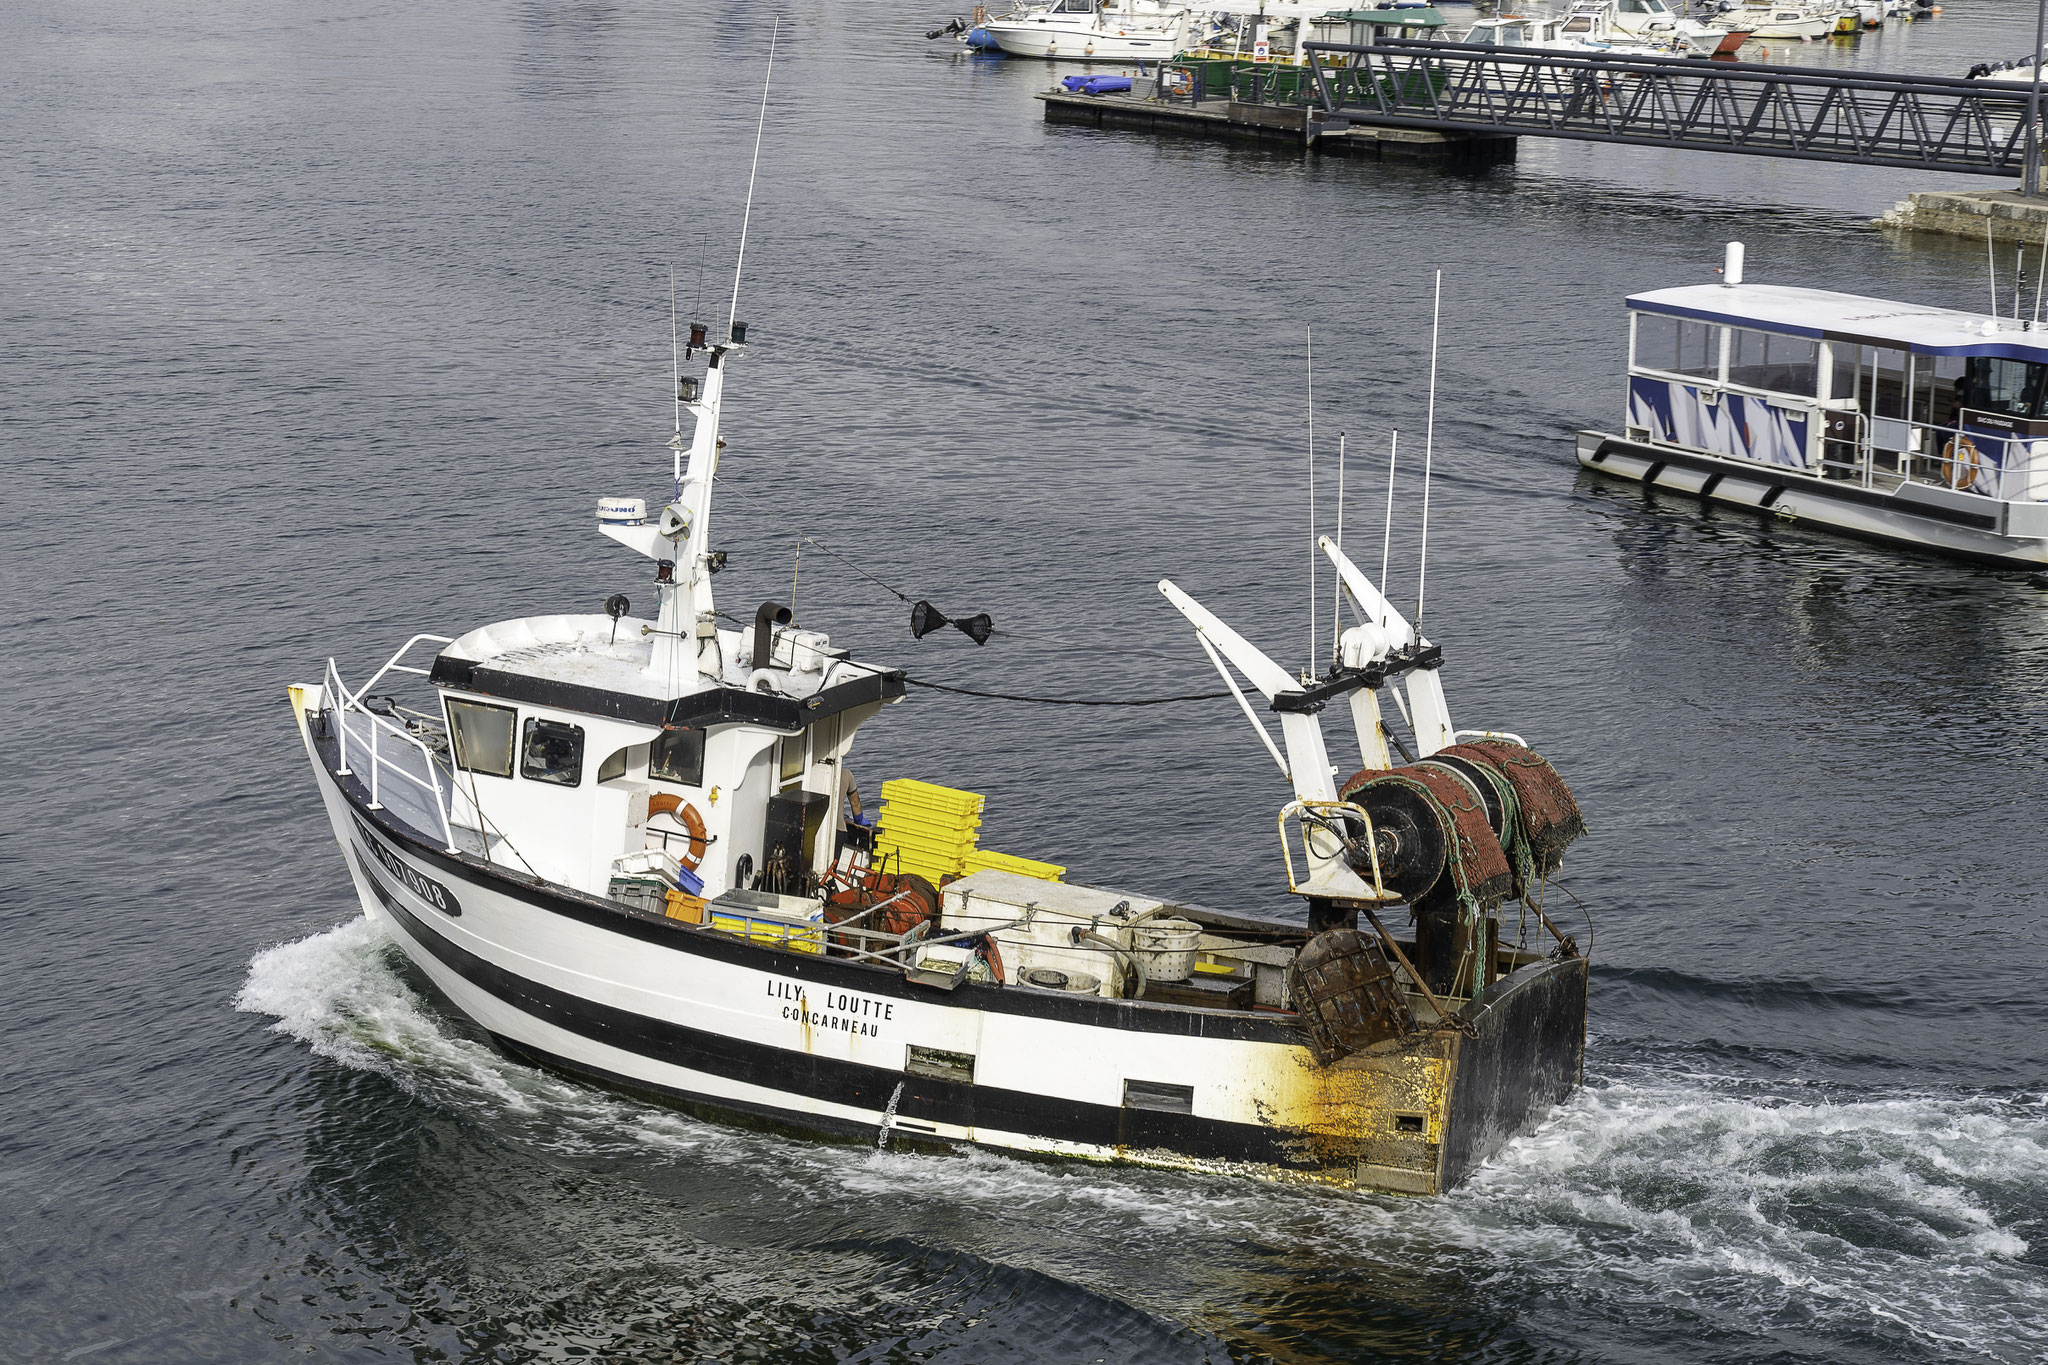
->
[236,919,2048,1363]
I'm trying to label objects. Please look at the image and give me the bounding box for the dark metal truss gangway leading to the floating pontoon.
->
[1198,37,2036,176]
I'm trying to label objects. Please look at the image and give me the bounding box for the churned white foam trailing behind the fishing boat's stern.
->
[1438,1074,2048,1361]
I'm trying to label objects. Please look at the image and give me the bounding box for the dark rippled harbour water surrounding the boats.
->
[12,0,2048,1365]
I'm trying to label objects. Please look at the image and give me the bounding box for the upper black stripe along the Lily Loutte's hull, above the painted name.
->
[317,741,1309,1048]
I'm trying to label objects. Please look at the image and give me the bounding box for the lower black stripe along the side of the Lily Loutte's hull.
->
[354,843,1313,1171]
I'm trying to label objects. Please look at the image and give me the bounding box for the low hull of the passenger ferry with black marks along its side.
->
[1577,432,2048,569]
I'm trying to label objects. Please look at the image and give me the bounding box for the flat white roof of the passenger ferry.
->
[1628,284,2048,362]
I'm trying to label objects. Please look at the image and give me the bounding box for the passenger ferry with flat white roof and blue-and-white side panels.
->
[1577,241,2048,569]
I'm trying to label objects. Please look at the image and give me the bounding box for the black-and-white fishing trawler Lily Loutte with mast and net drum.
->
[291,309,1587,1193]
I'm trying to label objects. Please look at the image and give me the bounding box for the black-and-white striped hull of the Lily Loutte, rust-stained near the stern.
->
[293,688,1585,1193]
